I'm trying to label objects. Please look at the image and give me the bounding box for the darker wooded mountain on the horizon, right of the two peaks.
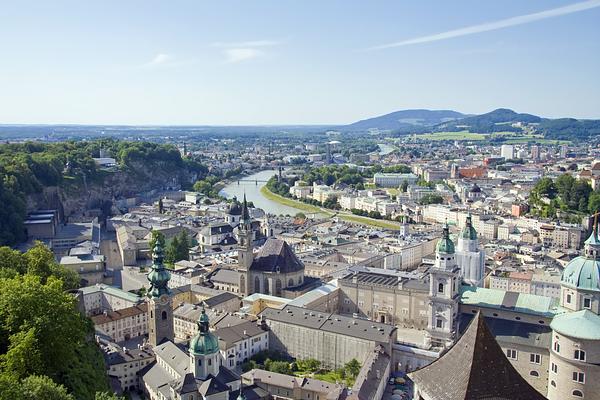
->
[434,108,543,133]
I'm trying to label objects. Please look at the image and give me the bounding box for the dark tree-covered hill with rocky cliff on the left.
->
[0,139,207,245]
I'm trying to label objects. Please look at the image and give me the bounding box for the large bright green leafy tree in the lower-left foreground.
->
[0,276,107,400]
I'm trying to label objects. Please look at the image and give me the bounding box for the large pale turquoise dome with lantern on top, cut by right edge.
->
[560,215,600,292]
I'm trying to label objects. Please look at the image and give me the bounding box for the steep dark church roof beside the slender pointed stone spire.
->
[250,238,304,273]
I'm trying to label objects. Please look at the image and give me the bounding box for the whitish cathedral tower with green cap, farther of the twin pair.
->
[456,214,485,287]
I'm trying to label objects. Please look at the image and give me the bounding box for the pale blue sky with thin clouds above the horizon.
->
[0,0,600,125]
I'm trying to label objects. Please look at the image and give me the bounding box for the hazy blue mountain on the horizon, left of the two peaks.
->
[336,110,467,132]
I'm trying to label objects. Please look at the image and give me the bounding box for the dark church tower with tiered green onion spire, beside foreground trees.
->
[148,236,175,346]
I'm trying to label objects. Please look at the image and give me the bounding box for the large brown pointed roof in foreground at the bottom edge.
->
[408,313,545,400]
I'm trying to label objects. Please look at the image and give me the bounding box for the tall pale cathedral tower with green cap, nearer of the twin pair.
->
[425,225,460,347]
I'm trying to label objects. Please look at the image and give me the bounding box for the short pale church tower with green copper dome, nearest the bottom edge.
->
[189,307,221,380]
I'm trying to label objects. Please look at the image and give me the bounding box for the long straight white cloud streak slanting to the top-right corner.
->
[367,0,600,50]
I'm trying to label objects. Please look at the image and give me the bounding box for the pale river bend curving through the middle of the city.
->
[219,170,302,215]
